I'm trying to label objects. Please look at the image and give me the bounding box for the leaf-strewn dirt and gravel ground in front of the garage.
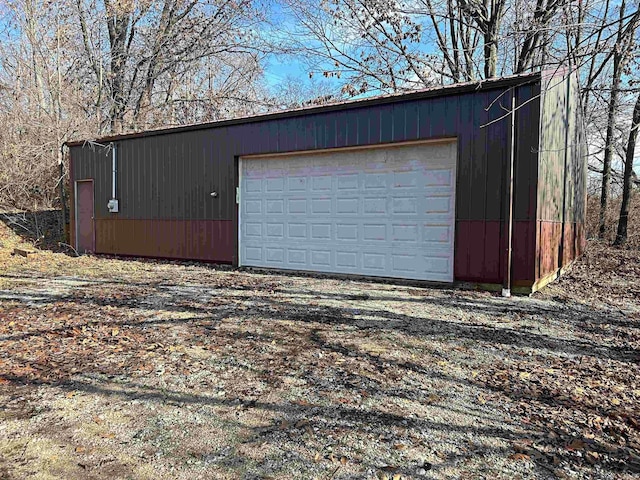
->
[0,226,640,480]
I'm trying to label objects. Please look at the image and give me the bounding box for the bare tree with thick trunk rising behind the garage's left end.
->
[75,0,268,132]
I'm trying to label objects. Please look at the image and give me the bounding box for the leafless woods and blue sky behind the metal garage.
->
[0,0,640,245]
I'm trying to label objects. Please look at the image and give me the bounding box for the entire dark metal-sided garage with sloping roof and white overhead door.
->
[67,71,586,293]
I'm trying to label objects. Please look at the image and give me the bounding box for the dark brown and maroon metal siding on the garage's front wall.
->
[71,76,539,284]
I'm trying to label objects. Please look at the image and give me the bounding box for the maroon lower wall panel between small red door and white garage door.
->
[96,219,235,263]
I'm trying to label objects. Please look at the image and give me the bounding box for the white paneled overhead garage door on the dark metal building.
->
[239,143,456,282]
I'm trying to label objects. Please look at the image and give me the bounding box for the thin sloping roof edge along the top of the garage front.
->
[64,72,541,147]
